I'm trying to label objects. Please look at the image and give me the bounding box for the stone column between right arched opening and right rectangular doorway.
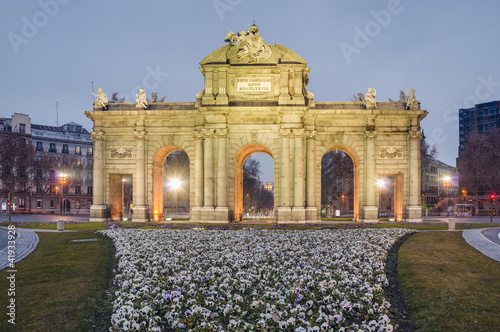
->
[363,130,378,222]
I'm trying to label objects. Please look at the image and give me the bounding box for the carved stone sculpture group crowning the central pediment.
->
[224,22,272,63]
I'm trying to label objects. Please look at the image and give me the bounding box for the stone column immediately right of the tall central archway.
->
[277,128,292,222]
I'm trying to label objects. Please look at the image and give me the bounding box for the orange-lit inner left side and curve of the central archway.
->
[234,144,274,221]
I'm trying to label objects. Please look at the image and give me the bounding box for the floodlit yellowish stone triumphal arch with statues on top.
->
[85,25,427,223]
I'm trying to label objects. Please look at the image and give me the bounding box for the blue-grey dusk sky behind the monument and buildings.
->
[0,0,500,180]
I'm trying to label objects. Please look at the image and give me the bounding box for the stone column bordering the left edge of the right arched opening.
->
[305,130,318,221]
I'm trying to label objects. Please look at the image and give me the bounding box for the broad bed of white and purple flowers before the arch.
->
[100,228,413,331]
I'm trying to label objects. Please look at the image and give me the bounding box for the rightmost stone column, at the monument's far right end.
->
[405,130,422,222]
